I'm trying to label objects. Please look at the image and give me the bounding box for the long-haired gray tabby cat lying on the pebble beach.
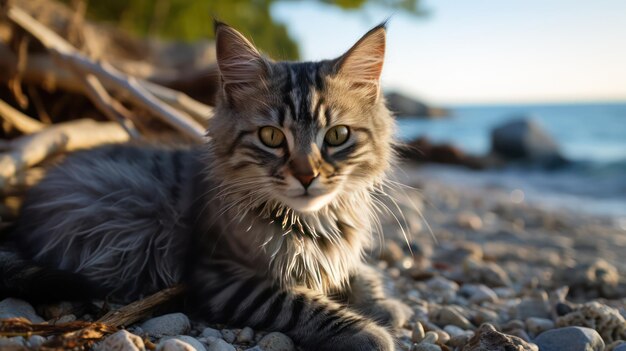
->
[9,23,411,350]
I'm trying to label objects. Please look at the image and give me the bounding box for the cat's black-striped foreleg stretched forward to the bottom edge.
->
[190,274,395,351]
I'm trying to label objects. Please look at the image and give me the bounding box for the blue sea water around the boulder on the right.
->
[398,103,626,218]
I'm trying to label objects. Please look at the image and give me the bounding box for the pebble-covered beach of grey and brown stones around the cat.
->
[0,160,626,351]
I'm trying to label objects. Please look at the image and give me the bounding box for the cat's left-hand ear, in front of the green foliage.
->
[214,21,268,102]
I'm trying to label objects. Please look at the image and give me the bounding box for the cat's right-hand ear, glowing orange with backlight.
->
[335,23,386,101]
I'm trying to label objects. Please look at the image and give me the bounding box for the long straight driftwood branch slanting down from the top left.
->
[8,6,204,142]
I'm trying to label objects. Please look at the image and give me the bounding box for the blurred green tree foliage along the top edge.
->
[62,0,421,59]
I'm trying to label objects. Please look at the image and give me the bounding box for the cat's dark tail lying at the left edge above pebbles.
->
[0,246,101,303]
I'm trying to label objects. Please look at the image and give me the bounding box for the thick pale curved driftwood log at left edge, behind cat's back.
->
[0,119,129,188]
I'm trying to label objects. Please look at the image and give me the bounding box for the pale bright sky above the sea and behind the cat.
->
[272,0,626,104]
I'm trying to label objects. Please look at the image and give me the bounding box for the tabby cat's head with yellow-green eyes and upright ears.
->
[209,23,393,213]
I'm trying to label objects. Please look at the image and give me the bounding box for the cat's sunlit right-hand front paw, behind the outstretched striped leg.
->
[345,264,413,328]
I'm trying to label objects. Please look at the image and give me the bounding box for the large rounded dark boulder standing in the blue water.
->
[491,118,567,167]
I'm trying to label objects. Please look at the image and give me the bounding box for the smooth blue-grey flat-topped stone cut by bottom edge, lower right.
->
[534,327,605,351]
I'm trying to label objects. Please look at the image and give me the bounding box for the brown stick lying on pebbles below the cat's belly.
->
[98,285,185,327]
